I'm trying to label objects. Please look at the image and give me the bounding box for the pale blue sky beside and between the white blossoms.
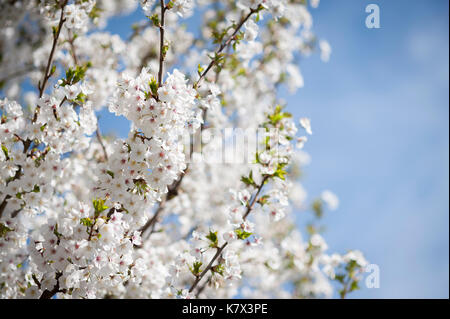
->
[101,0,449,298]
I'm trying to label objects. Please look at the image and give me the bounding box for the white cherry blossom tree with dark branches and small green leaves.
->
[0,0,367,299]
